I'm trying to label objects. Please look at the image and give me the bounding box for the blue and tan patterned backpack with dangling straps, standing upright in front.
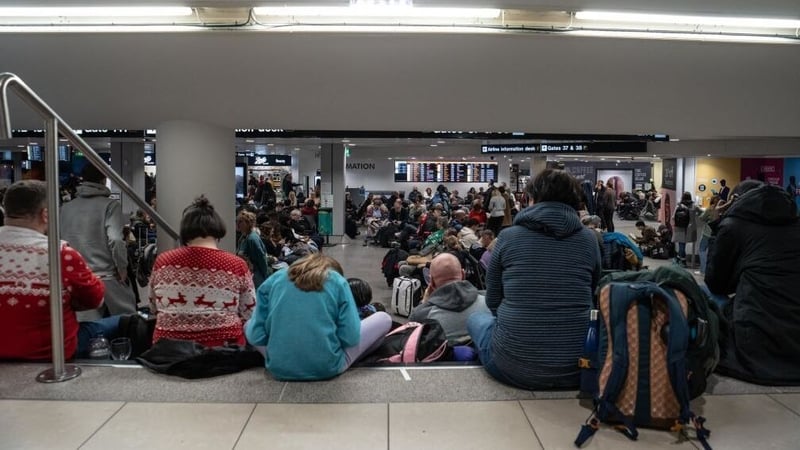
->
[575,281,710,449]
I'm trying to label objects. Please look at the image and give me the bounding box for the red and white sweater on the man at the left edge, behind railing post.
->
[0,226,105,361]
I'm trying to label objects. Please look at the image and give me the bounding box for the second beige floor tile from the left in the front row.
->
[82,403,255,450]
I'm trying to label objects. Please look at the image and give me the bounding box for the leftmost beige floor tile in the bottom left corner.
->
[0,400,123,449]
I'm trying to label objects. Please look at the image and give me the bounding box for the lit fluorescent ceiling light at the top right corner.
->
[575,11,800,29]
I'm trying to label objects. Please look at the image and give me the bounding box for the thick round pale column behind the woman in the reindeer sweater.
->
[156,120,236,252]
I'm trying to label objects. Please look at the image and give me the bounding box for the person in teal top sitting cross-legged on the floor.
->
[245,253,392,381]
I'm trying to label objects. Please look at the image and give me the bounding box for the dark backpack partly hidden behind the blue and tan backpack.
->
[597,265,727,399]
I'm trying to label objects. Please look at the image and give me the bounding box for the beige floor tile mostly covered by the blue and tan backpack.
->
[520,400,696,450]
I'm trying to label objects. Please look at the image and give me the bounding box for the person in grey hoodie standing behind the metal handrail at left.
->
[61,164,136,320]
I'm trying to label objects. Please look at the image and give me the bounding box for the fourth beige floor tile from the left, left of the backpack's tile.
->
[389,401,541,450]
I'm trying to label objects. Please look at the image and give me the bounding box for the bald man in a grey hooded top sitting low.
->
[408,253,489,345]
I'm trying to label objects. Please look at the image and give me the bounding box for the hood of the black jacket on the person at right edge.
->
[725,185,797,225]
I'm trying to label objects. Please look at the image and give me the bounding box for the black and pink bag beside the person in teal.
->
[369,319,452,363]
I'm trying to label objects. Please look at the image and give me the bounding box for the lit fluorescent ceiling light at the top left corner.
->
[0,6,192,17]
